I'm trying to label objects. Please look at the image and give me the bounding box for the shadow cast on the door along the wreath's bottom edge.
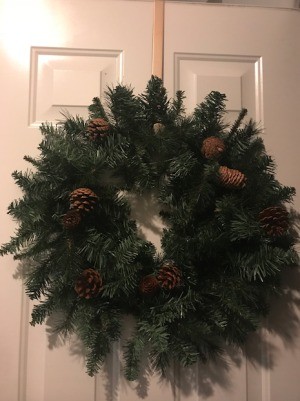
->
[41,262,300,401]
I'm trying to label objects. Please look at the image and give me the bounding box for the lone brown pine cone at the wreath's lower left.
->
[74,269,102,299]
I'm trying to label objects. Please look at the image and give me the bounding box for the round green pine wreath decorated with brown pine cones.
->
[1,77,298,380]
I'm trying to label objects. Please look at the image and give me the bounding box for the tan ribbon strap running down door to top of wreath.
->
[152,0,165,79]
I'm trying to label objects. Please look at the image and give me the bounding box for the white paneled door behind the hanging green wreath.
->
[0,0,300,401]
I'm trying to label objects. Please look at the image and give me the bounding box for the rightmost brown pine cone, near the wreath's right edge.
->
[259,206,289,237]
